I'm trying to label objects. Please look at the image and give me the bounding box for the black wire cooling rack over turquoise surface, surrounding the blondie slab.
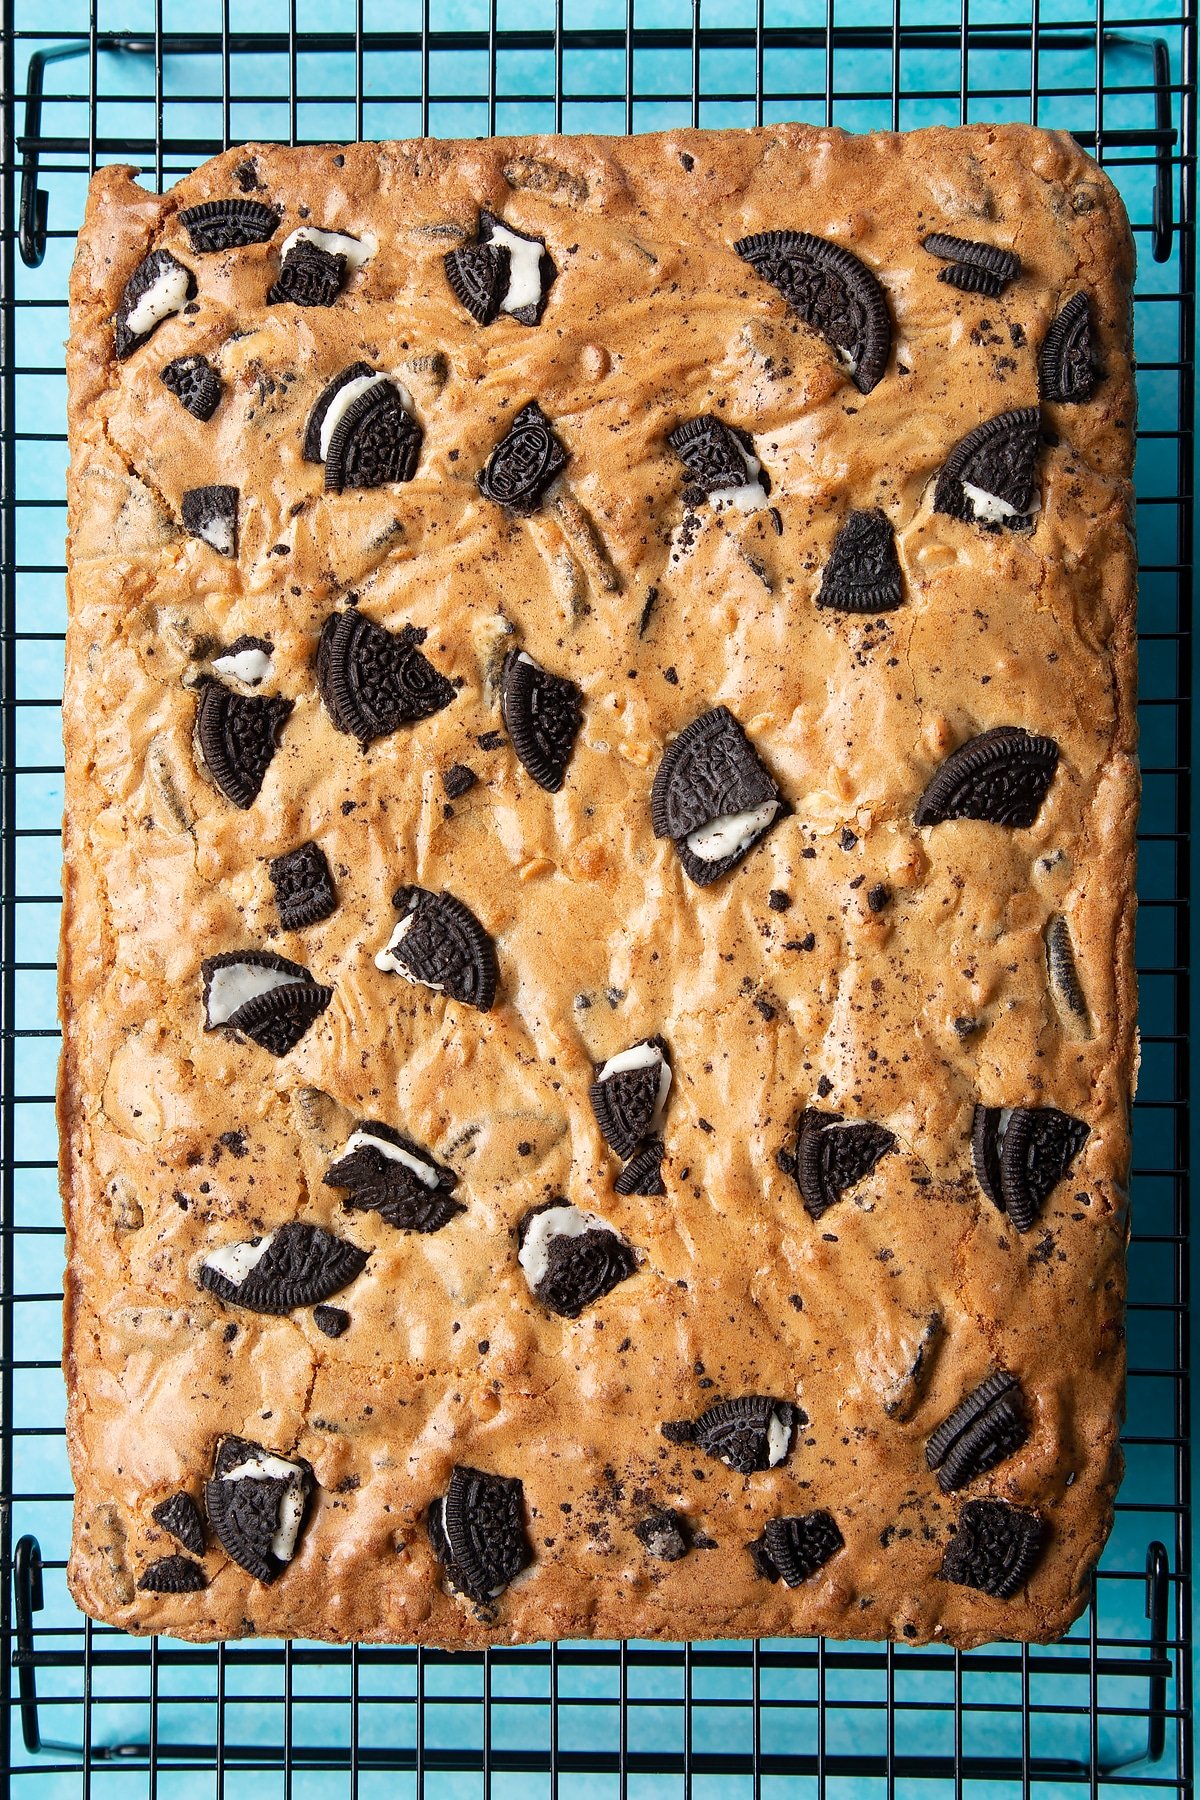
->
[0,0,1196,1800]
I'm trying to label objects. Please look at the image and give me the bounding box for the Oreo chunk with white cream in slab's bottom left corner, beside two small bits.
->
[203,1436,313,1582]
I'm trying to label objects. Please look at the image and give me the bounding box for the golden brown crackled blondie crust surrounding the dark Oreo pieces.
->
[59,126,1137,1647]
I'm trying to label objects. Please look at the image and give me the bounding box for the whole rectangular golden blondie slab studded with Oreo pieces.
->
[59,126,1137,1647]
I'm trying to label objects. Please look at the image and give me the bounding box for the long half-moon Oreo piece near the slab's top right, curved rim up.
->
[734,230,892,394]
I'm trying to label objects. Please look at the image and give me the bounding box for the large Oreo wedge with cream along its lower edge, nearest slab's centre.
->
[649,706,786,887]
